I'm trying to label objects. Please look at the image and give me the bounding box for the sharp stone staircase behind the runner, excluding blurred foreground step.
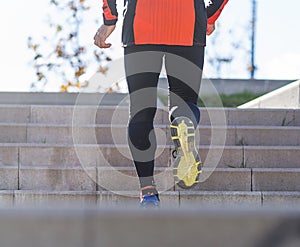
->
[0,105,300,208]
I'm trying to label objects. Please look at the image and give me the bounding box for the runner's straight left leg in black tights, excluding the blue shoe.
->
[125,45,163,193]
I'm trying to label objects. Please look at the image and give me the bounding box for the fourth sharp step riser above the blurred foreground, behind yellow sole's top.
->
[0,123,300,146]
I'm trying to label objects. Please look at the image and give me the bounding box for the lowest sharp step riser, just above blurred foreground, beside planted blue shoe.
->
[0,190,300,209]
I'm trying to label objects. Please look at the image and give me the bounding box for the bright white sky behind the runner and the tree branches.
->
[0,0,300,91]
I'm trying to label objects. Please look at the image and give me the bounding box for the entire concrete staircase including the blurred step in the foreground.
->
[0,102,300,247]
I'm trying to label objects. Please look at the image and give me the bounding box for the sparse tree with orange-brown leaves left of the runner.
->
[28,0,111,92]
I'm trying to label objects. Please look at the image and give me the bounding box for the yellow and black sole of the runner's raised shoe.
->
[170,117,202,189]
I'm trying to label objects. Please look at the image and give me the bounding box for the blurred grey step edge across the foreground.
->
[0,209,300,247]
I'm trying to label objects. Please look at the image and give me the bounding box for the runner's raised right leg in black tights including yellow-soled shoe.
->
[166,46,204,188]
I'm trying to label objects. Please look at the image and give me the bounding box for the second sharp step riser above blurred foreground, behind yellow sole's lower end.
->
[0,168,300,191]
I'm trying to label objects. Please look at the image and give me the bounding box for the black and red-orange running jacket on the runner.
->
[103,0,228,46]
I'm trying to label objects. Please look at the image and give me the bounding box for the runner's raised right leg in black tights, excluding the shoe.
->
[165,46,204,128]
